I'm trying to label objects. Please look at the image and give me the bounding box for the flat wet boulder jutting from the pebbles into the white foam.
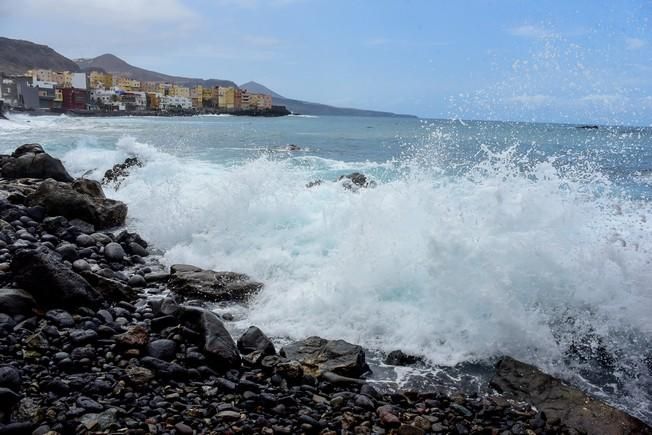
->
[168,265,263,302]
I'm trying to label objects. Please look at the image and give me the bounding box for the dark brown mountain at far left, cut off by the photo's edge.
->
[0,37,79,74]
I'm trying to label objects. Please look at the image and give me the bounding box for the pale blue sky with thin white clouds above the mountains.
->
[0,0,652,125]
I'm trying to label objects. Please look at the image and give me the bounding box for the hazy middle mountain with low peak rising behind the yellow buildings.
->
[75,53,237,87]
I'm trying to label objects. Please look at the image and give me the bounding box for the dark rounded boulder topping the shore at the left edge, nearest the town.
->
[0,144,73,183]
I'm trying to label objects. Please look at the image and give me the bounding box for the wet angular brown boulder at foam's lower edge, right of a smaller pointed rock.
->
[280,337,369,377]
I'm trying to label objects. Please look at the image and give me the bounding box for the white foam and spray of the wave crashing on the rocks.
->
[26,129,652,422]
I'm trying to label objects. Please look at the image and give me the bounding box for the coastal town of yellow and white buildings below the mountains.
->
[0,69,289,116]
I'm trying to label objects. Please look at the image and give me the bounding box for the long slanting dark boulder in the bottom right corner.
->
[490,357,652,434]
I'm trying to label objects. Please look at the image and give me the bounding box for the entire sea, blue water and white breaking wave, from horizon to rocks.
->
[0,115,652,422]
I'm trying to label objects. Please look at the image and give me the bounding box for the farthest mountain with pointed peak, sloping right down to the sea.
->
[240,81,413,117]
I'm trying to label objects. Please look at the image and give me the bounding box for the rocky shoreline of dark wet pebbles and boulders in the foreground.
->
[0,144,652,435]
